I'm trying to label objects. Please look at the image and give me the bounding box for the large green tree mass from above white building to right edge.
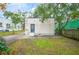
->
[34,3,79,33]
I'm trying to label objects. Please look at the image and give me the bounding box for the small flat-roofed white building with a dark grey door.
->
[25,18,55,36]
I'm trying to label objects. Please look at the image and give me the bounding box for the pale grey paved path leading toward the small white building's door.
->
[3,33,27,43]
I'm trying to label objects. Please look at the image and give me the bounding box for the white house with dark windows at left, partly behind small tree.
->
[0,17,21,31]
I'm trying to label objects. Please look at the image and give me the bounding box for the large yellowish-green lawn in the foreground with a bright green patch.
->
[9,37,79,55]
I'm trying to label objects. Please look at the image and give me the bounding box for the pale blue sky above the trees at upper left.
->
[0,3,38,17]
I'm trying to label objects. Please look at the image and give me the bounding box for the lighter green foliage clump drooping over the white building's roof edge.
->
[33,4,50,22]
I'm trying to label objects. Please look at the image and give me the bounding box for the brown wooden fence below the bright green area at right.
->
[62,29,79,40]
